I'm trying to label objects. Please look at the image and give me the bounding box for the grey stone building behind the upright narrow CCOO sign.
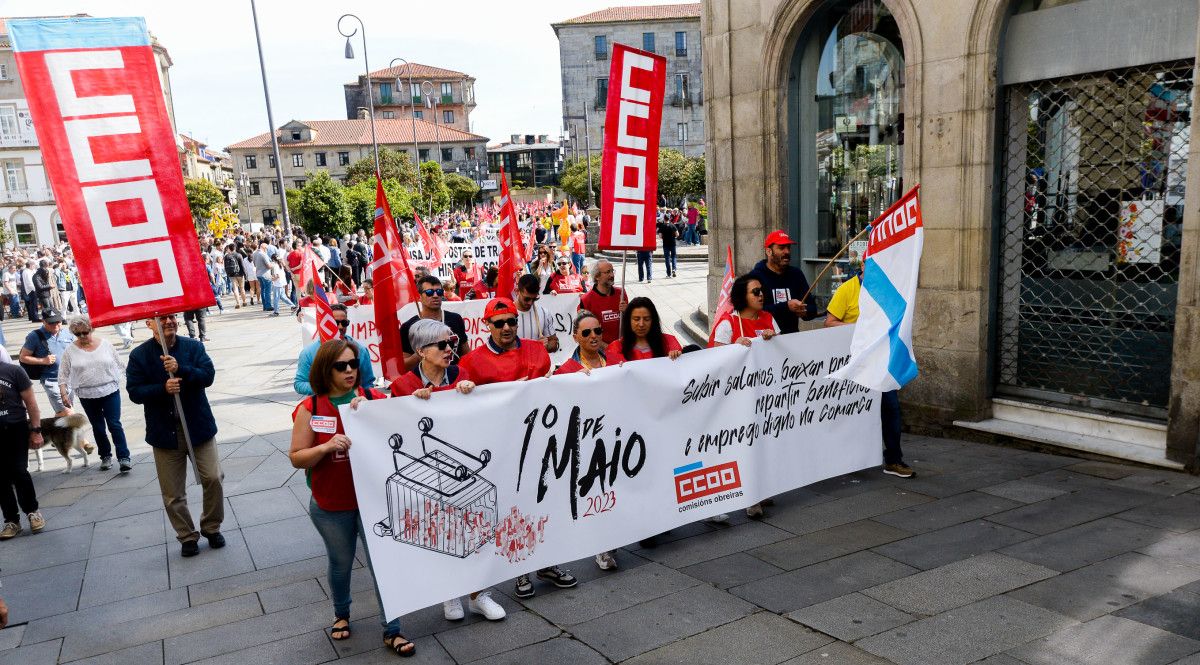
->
[552,2,704,157]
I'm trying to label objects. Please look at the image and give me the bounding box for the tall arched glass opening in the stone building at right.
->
[786,0,905,299]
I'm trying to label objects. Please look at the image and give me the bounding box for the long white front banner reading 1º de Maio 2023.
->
[342,326,882,618]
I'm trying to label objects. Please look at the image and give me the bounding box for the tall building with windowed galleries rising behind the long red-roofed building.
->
[344,62,475,132]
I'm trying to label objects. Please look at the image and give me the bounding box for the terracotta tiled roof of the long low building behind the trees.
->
[227,119,487,150]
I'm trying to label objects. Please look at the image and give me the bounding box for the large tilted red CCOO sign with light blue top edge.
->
[8,17,214,326]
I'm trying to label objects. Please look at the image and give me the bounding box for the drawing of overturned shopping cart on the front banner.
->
[374,418,497,558]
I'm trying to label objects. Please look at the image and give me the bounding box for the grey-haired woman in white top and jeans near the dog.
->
[59,316,133,473]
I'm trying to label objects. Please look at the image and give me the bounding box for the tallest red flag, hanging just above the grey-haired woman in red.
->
[370,173,416,382]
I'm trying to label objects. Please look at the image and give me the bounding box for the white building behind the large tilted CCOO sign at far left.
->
[0,14,177,246]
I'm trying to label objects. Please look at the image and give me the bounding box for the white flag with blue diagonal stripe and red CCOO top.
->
[829,185,925,391]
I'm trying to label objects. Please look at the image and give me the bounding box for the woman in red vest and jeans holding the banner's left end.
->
[288,340,416,657]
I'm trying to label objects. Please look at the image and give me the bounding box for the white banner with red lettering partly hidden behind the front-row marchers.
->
[300,293,580,377]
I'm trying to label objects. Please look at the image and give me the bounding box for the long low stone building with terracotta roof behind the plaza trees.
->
[227,118,487,226]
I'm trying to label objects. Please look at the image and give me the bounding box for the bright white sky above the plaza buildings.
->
[0,0,677,149]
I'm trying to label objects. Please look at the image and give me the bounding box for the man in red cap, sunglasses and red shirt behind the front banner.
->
[458,298,580,598]
